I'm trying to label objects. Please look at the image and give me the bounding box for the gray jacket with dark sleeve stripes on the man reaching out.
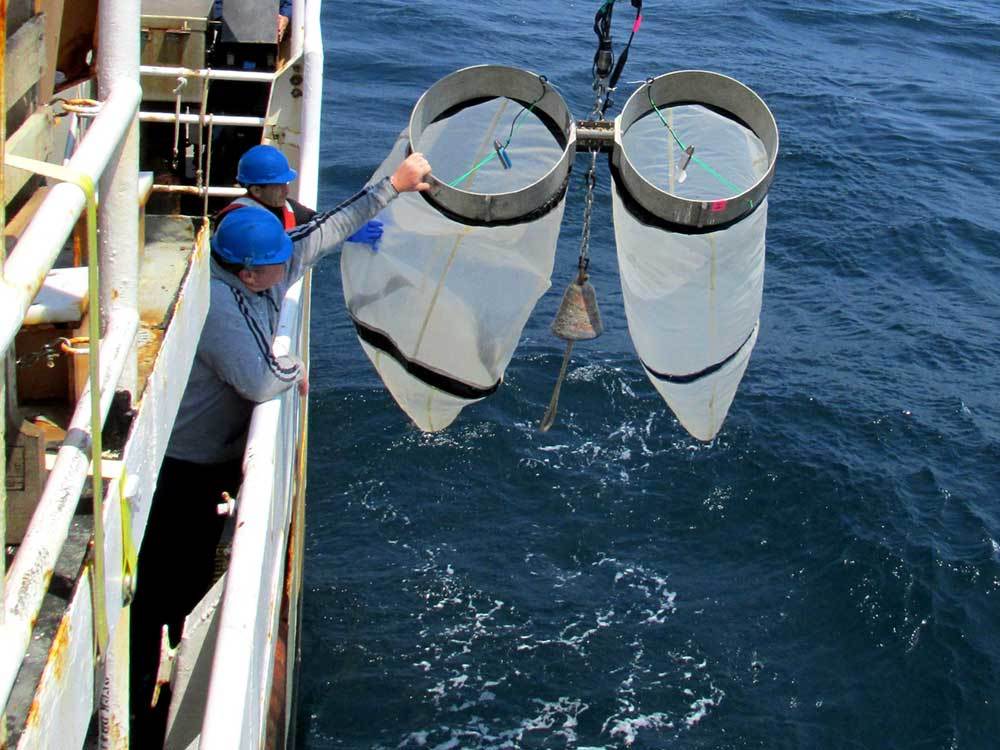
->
[167,178,397,464]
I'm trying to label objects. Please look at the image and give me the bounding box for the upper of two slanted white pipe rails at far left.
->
[0,82,141,362]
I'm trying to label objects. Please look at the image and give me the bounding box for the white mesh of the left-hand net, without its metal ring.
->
[341,97,565,432]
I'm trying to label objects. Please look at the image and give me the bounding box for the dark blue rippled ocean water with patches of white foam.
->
[297,0,1000,750]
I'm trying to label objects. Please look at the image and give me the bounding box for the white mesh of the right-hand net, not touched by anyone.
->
[612,105,768,440]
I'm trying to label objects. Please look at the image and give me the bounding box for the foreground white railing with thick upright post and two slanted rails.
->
[0,3,141,739]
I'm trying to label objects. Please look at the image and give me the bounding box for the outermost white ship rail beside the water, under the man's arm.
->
[200,0,323,750]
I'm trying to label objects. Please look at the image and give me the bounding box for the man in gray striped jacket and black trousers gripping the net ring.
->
[130,148,430,747]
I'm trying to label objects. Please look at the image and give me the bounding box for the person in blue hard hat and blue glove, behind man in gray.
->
[214,144,382,249]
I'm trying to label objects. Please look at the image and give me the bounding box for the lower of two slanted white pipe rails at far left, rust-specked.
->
[0,310,138,716]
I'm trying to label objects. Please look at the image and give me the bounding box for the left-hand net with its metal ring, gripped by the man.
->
[341,65,576,432]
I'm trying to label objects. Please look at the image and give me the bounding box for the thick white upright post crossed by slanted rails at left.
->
[91,2,141,398]
